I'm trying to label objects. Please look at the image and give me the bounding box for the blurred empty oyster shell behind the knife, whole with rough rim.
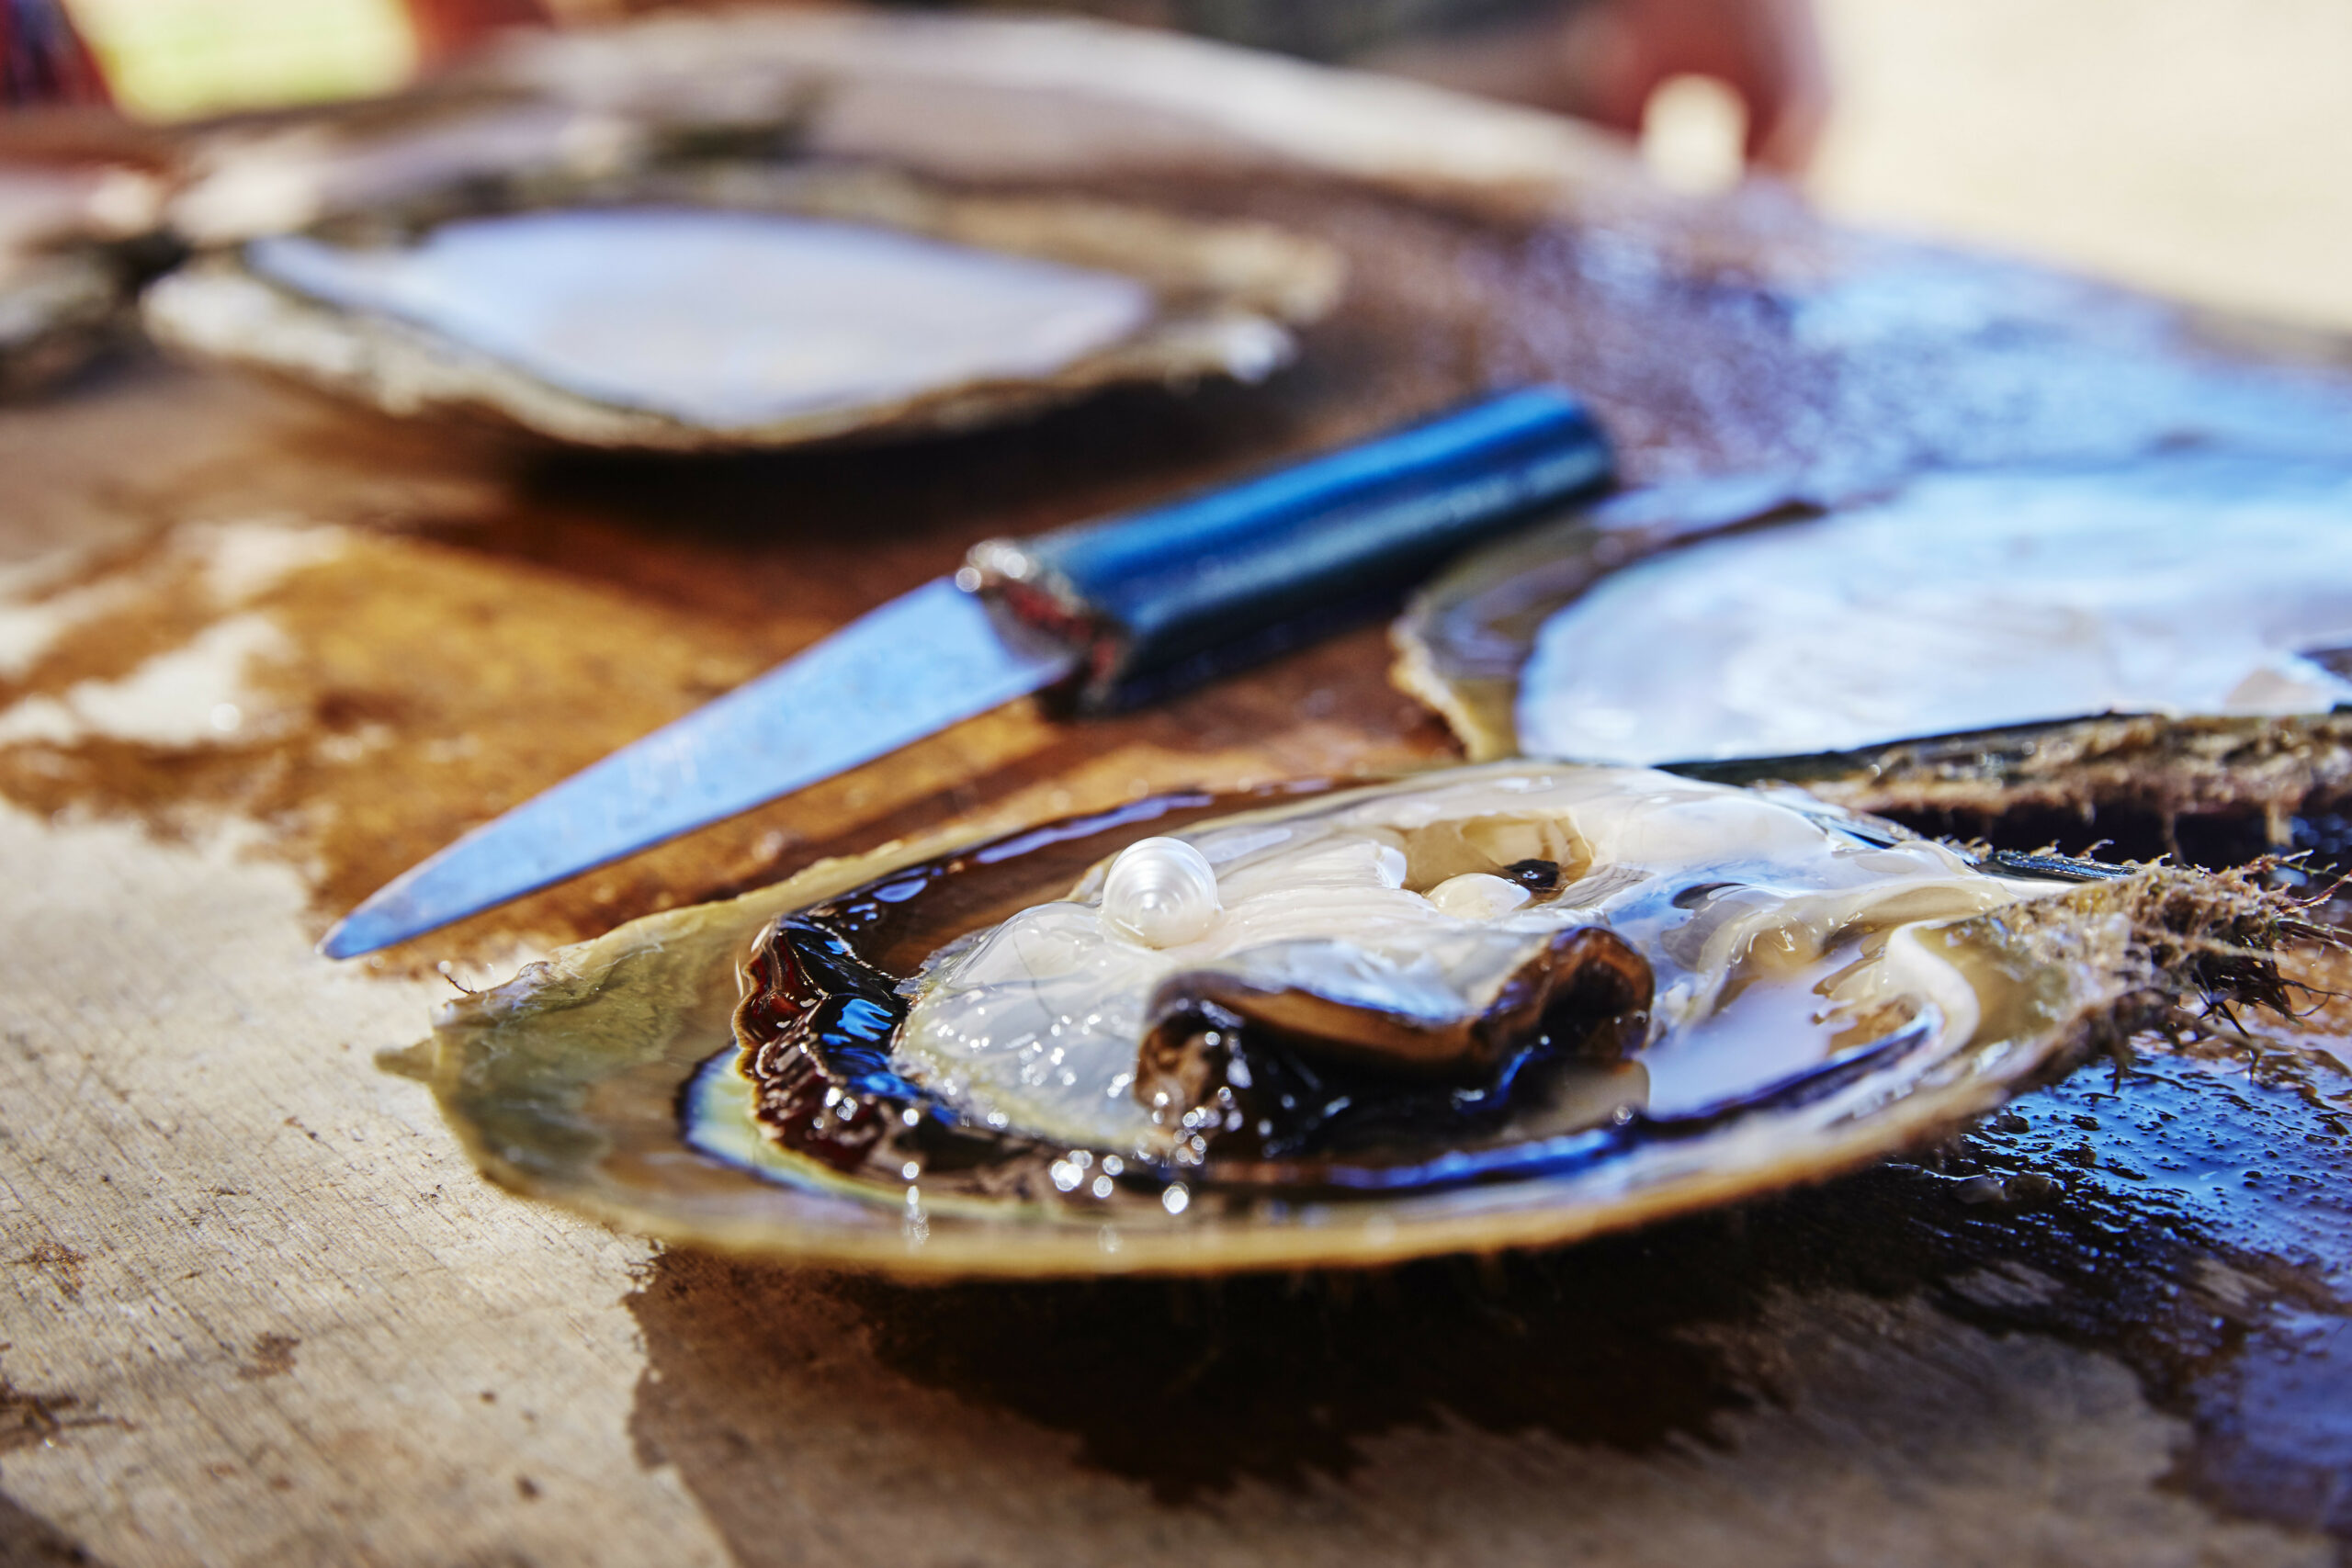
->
[143,164,1340,449]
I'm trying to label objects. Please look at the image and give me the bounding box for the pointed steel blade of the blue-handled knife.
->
[318,579,1077,959]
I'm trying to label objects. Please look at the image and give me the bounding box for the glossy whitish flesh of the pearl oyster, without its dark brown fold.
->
[891,764,2028,1161]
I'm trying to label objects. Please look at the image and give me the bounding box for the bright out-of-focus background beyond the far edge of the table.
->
[18,0,2352,329]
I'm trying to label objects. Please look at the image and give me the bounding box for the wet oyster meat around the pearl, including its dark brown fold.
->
[891,769,2049,1164]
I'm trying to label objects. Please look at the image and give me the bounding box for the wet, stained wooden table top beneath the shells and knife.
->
[14,15,2352,1568]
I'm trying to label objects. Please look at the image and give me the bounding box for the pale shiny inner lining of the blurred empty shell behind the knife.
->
[247,207,1152,428]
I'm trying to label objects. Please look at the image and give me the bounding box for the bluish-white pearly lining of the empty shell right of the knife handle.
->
[1517,456,2352,764]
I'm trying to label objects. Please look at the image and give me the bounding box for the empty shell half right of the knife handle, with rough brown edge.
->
[1395,451,2352,863]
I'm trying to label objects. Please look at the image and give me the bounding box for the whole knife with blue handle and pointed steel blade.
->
[318,388,1611,959]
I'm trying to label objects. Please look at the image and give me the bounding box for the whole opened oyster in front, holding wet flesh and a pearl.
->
[409,764,2269,1274]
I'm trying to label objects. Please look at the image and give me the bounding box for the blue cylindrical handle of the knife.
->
[957,388,1611,712]
